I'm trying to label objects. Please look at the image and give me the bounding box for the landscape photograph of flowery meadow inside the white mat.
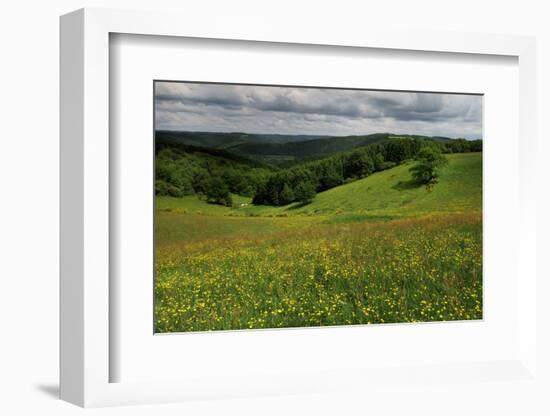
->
[152,80,483,333]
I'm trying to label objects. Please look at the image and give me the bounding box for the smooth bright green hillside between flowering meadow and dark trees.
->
[157,153,482,221]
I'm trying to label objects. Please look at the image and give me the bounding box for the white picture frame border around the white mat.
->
[60,9,538,407]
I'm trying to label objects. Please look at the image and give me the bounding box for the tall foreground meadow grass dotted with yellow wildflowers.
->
[155,212,482,332]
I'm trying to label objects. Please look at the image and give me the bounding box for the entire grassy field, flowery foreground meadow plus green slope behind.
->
[155,153,482,332]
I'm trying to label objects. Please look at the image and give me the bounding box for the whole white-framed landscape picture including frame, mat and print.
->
[61,9,539,409]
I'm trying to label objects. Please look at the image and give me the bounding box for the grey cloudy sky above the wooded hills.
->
[155,82,482,139]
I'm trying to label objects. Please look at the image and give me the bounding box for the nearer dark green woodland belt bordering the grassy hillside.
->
[155,137,482,206]
